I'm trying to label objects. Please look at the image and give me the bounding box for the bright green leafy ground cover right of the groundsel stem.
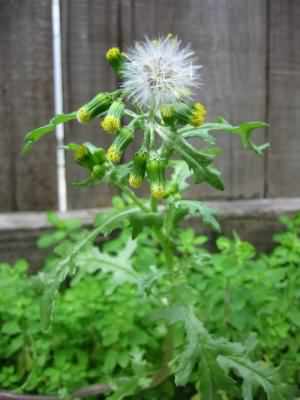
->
[189,219,300,396]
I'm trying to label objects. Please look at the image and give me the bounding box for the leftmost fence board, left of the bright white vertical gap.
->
[0,0,56,211]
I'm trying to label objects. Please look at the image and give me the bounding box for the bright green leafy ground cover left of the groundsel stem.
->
[0,225,166,396]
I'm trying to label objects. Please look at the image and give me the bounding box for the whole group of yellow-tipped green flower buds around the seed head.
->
[69,43,206,200]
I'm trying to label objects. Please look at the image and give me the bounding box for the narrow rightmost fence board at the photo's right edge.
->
[268,0,300,197]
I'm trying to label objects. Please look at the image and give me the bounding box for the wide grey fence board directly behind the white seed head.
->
[121,0,266,198]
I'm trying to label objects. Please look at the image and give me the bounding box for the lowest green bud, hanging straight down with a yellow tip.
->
[146,153,167,199]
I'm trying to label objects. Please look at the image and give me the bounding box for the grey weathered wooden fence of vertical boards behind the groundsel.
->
[0,0,300,211]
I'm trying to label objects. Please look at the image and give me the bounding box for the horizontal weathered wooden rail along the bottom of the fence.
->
[0,198,300,267]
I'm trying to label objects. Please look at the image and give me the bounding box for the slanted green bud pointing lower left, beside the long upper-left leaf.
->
[77,92,114,124]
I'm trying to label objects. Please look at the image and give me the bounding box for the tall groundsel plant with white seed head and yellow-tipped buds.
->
[24,35,287,400]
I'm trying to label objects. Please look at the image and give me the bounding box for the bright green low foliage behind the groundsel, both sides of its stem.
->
[0,206,300,400]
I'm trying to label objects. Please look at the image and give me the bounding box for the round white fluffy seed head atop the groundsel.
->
[122,35,201,109]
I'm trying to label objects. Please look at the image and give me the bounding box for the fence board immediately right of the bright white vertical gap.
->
[61,0,119,209]
